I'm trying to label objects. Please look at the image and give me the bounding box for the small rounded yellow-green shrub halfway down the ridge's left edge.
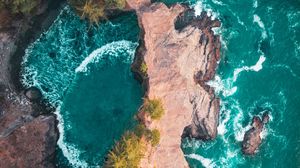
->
[142,99,164,120]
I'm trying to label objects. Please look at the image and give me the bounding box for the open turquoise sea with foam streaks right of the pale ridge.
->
[178,0,300,167]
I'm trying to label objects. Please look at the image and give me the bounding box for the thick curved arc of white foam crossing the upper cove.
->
[75,40,137,73]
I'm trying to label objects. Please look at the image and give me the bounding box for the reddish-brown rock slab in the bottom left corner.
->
[0,116,58,168]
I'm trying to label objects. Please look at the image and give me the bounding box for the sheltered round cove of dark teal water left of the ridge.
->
[22,6,143,167]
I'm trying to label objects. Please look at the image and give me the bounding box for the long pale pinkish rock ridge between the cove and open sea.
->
[133,3,220,168]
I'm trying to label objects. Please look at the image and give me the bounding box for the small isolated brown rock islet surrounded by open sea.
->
[242,113,269,155]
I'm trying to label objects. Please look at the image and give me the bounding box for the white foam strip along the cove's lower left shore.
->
[55,106,88,168]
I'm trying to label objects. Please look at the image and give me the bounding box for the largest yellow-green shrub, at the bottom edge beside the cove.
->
[104,132,146,168]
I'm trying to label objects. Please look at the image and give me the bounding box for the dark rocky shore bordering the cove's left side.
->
[0,0,60,168]
